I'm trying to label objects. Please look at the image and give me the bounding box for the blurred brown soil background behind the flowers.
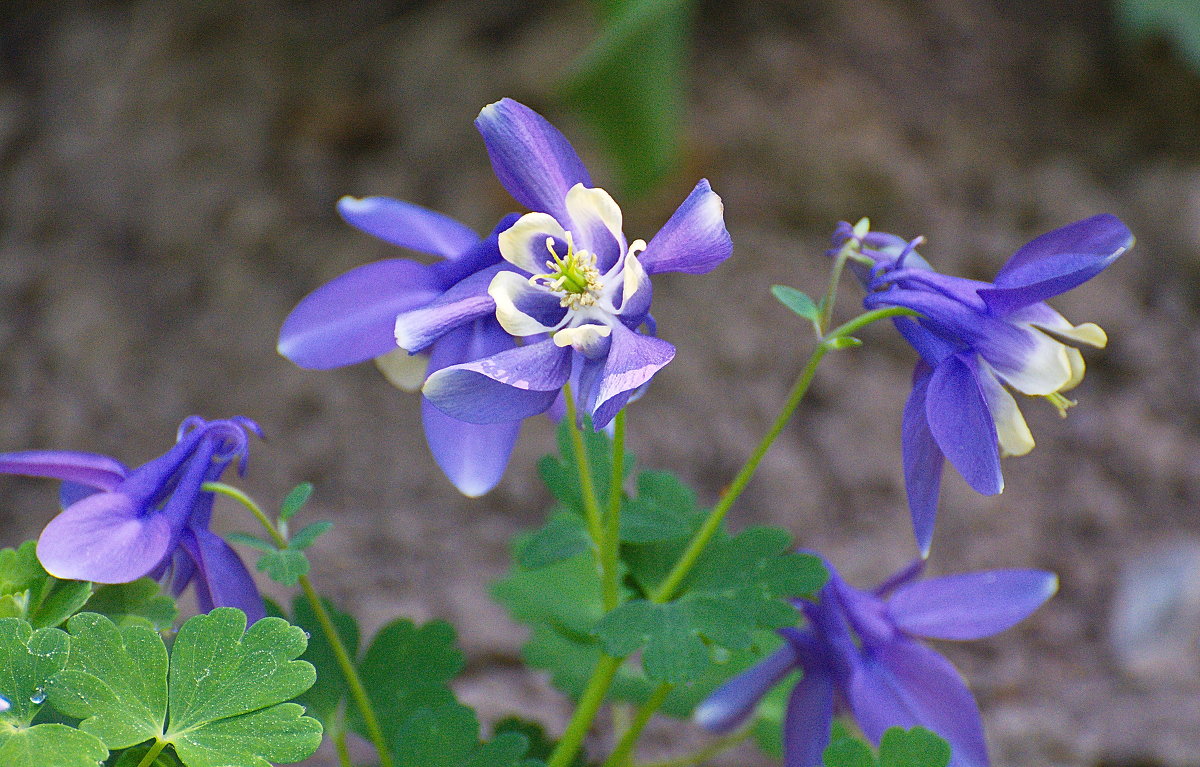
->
[0,0,1200,767]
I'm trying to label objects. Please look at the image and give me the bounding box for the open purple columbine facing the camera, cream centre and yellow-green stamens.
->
[422,98,732,429]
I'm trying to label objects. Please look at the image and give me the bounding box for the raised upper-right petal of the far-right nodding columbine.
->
[979,214,1133,314]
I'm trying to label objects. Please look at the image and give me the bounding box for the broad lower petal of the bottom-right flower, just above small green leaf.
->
[846,637,988,767]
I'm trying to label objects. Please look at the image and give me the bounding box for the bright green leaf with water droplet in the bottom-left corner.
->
[0,618,108,767]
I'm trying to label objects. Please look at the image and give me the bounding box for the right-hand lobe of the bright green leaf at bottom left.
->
[163,607,322,767]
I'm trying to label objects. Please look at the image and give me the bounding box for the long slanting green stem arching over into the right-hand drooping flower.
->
[650,301,916,603]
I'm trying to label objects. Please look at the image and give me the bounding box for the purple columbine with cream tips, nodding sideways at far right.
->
[834,215,1133,555]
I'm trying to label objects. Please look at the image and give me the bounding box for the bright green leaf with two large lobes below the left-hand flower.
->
[48,607,322,767]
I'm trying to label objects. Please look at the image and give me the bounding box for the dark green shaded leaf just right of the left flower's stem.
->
[347,618,466,742]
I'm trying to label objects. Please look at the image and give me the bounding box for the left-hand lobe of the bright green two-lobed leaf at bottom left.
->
[47,612,168,749]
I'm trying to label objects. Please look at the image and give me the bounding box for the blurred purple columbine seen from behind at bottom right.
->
[694,559,1058,767]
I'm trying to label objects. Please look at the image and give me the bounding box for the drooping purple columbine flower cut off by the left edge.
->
[0,415,266,622]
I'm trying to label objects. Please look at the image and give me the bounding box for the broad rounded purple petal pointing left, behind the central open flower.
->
[277,258,440,370]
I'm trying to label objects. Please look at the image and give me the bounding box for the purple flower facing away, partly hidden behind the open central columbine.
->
[278,197,530,497]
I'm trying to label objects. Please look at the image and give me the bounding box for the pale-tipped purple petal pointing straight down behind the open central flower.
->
[421,319,521,498]
